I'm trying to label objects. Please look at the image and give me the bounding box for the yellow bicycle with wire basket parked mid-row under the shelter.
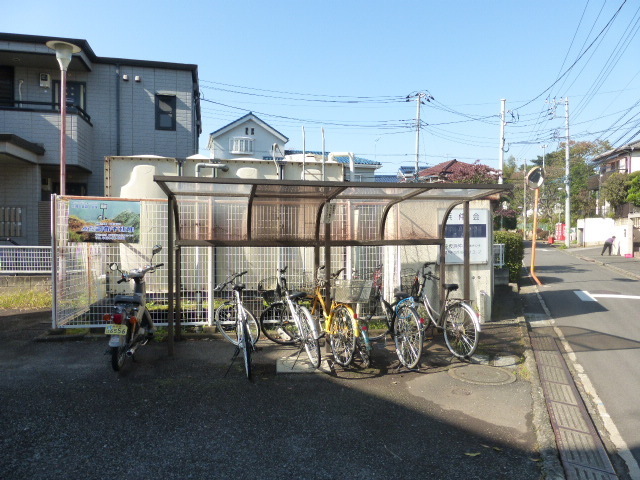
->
[311,266,368,367]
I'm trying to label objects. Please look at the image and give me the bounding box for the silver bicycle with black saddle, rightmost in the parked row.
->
[411,262,480,359]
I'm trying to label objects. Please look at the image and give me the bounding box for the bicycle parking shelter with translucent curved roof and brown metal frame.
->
[154,176,513,354]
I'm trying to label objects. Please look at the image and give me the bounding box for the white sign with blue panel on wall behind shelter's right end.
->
[444,208,491,264]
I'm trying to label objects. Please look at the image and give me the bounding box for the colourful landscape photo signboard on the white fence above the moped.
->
[69,199,140,243]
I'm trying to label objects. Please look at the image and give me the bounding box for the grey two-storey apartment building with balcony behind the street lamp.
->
[0,33,202,245]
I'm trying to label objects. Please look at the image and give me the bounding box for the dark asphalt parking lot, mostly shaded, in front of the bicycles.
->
[0,314,541,480]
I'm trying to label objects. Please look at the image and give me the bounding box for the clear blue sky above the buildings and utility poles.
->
[0,0,640,173]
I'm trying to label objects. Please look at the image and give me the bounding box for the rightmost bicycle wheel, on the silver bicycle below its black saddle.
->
[443,303,480,358]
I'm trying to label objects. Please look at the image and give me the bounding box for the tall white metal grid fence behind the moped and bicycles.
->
[53,197,384,328]
